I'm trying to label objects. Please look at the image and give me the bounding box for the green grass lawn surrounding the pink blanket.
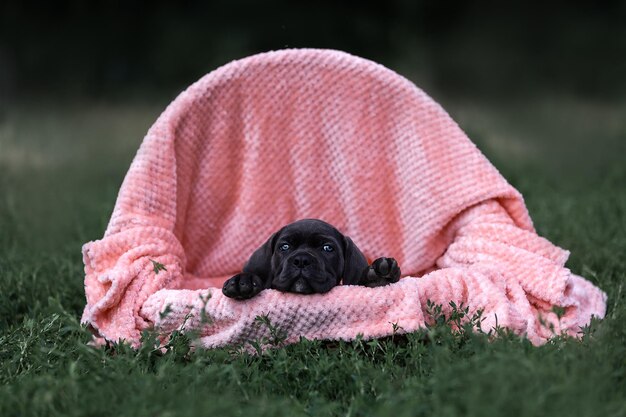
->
[0,98,626,417]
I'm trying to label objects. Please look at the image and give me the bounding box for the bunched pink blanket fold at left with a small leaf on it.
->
[82,227,185,341]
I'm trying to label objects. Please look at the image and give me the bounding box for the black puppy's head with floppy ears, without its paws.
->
[244,219,367,294]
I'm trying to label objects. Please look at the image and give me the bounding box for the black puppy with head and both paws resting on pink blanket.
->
[222,219,400,300]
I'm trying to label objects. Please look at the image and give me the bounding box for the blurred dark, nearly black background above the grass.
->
[0,0,626,104]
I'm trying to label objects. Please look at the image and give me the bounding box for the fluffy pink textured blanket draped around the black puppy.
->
[83,50,606,347]
